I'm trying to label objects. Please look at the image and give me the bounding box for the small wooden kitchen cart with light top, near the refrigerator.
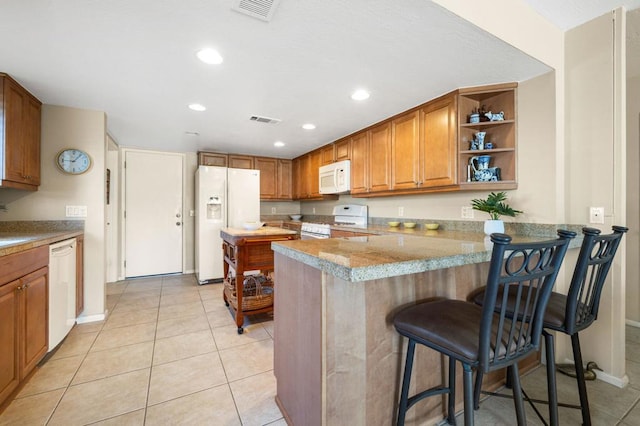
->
[220,226,297,334]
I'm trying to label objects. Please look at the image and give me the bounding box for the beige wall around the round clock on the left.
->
[0,105,106,317]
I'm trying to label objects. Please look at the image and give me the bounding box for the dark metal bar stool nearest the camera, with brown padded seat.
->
[394,231,576,425]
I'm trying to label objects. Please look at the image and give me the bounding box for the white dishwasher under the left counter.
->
[49,238,76,351]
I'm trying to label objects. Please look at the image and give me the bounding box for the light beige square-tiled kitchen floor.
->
[0,275,640,426]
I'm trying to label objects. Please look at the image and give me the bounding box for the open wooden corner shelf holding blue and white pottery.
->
[458,83,518,190]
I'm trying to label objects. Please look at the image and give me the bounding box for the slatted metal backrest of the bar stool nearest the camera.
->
[478,230,576,372]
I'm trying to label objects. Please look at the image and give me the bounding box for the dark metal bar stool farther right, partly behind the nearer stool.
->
[469,226,628,426]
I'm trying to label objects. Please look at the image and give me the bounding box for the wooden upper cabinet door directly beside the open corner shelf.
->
[420,96,457,188]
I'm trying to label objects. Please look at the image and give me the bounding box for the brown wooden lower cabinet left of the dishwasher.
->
[0,246,49,404]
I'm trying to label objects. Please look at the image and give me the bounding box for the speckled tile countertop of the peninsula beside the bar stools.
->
[271,227,582,282]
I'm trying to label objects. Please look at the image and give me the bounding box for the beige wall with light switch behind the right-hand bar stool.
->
[558,12,626,384]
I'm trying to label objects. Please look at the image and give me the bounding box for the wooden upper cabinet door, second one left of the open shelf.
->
[391,111,420,190]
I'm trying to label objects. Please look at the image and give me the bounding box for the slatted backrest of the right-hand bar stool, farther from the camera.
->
[564,226,628,335]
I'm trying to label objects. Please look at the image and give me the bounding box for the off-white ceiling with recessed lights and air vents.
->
[0,0,640,158]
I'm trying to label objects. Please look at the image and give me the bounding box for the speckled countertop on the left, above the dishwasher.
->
[0,221,84,256]
